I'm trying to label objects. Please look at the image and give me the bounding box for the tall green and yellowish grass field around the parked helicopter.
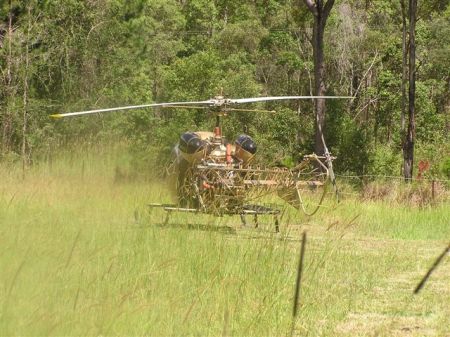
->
[0,150,450,336]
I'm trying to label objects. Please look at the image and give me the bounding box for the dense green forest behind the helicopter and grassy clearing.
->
[0,0,450,179]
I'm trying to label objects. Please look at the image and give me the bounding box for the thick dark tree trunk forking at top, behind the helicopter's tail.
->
[304,0,334,155]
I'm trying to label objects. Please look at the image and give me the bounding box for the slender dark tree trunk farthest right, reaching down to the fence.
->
[403,0,417,181]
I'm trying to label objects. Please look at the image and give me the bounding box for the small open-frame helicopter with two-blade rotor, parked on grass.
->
[51,95,352,232]
